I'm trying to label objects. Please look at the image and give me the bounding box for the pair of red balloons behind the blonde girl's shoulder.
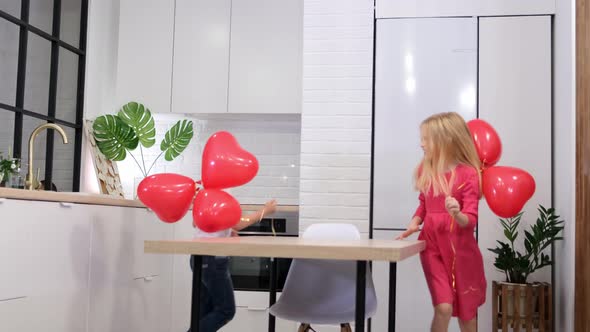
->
[467,119,535,218]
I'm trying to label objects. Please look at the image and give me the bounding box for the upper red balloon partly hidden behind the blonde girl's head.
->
[467,119,502,168]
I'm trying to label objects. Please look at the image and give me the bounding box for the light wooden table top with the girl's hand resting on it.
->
[144,236,426,262]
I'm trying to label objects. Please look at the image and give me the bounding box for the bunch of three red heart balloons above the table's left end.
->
[137,131,258,232]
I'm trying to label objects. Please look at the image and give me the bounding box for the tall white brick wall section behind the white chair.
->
[300,0,374,233]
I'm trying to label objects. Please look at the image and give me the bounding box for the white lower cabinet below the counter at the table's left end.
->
[88,206,173,332]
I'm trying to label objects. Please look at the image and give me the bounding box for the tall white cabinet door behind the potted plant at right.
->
[479,16,552,331]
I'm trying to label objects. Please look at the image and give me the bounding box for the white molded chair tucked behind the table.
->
[270,224,377,325]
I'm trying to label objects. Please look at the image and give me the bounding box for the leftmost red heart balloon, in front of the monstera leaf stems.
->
[137,173,196,223]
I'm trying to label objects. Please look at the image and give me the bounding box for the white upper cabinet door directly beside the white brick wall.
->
[228,0,303,113]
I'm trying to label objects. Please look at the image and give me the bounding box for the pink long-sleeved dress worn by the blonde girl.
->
[414,165,487,321]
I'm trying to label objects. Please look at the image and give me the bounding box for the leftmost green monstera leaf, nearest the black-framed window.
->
[92,114,139,161]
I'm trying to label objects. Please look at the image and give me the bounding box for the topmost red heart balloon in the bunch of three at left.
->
[201,131,258,189]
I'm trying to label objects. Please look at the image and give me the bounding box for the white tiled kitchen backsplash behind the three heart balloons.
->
[118,114,301,205]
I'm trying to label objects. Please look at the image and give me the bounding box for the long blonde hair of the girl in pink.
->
[414,112,481,197]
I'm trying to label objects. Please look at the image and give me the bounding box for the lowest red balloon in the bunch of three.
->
[193,189,242,233]
